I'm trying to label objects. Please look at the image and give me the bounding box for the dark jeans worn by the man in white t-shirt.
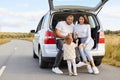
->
[53,39,80,67]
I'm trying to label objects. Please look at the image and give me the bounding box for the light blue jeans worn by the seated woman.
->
[80,38,94,61]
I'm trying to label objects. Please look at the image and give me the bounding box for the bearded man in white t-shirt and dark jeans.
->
[52,15,84,74]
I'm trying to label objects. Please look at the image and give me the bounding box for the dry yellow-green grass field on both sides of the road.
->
[0,33,120,67]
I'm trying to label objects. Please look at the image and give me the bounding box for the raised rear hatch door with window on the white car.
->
[49,0,108,12]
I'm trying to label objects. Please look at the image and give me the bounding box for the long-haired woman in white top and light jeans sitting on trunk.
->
[74,16,99,74]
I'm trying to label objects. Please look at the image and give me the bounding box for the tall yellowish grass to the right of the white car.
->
[103,34,120,67]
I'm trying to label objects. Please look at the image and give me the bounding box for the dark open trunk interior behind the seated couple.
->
[51,11,100,49]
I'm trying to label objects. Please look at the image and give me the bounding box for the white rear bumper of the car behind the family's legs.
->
[42,45,105,62]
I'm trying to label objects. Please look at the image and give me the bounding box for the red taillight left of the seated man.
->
[44,31,56,44]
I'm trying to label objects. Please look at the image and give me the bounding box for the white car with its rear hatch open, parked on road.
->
[32,0,108,68]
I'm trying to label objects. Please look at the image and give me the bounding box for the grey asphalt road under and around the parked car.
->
[0,40,120,80]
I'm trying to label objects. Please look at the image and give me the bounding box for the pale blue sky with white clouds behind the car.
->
[0,0,120,32]
